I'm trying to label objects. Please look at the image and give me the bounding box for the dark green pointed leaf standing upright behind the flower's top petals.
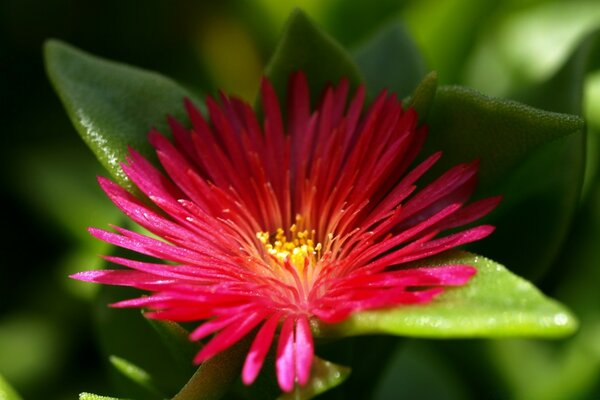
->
[265,9,362,104]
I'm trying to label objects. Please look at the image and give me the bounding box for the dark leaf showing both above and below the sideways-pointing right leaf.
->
[473,32,600,279]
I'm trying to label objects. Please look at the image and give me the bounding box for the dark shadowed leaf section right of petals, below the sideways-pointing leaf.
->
[471,131,585,280]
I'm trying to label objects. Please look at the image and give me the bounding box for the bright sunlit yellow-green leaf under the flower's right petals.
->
[313,251,577,338]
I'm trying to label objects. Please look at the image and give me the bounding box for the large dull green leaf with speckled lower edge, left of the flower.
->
[44,40,199,189]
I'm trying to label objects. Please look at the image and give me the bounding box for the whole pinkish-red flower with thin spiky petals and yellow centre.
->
[73,73,499,392]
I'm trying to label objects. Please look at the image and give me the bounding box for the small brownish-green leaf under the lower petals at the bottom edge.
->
[173,337,250,400]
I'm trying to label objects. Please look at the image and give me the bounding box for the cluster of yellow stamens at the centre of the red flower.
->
[256,215,322,271]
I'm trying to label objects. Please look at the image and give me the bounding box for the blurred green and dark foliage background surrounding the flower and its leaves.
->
[0,0,600,399]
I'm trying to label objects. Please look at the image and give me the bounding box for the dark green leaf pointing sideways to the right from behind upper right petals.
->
[425,86,584,191]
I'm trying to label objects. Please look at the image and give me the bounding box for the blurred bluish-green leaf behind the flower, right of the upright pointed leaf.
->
[354,24,427,97]
